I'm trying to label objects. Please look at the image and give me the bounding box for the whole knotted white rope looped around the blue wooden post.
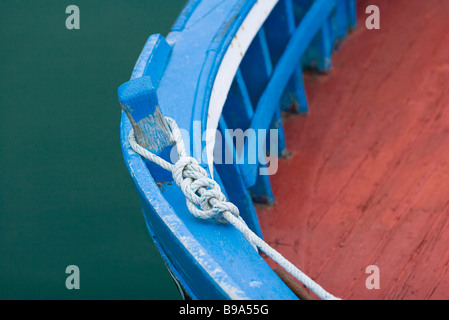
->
[129,117,340,300]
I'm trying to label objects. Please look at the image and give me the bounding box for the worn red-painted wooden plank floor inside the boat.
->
[258,0,449,299]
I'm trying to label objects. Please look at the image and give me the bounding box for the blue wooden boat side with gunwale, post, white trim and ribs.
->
[118,0,356,300]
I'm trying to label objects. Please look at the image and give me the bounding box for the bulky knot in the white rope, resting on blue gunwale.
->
[173,157,239,223]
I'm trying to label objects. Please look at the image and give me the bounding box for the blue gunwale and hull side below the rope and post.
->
[121,111,295,299]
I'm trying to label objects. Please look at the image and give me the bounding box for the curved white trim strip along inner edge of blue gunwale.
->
[206,0,279,178]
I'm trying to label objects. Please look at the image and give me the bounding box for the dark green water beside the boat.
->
[0,0,185,299]
